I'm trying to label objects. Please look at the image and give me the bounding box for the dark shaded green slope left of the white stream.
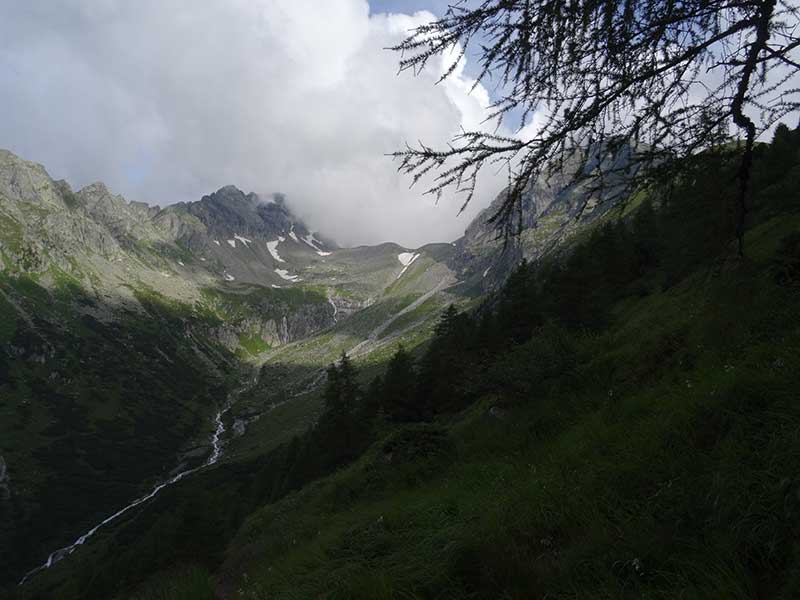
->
[0,271,238,583]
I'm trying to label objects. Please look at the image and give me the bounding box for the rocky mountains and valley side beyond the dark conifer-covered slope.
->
[0,143,636,592]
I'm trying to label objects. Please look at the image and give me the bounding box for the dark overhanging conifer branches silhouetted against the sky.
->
[393,0,800,252]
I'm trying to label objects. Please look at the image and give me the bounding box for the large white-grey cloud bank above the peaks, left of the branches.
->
[0,0,502,246]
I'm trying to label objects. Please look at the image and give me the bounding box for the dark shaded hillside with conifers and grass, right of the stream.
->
[10,124,800,600]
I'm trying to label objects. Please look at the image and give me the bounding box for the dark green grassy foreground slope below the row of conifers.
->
[219,207,800,599]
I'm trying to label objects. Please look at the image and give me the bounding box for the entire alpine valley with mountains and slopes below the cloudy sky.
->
[0,126,800,600]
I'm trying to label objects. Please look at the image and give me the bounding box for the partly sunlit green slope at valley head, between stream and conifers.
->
[222,245,470,459]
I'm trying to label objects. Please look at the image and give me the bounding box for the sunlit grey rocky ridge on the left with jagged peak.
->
[0,150,332,292]
